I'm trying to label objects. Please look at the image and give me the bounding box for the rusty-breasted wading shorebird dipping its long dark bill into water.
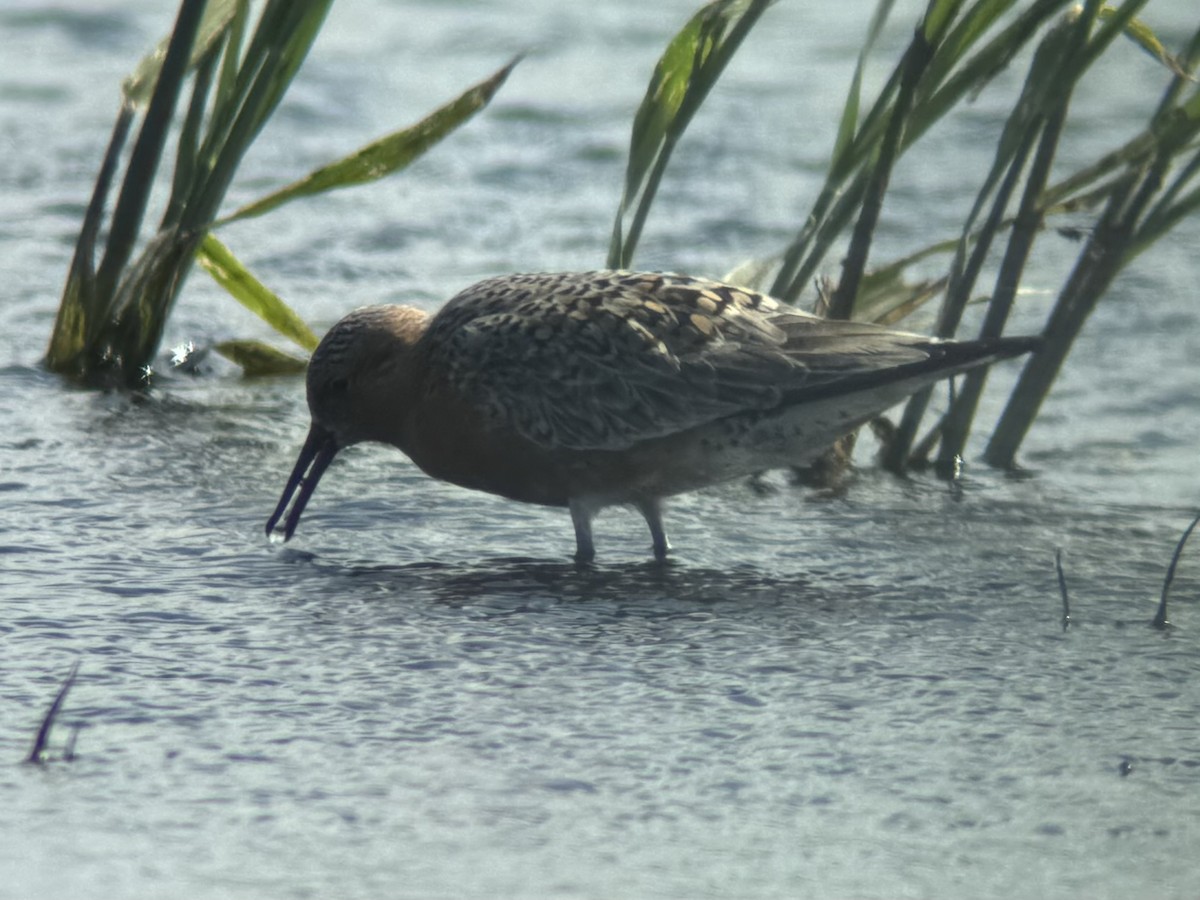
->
[266,271,1037,562]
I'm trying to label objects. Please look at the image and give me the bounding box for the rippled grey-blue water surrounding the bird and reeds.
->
[0,0,1200,898]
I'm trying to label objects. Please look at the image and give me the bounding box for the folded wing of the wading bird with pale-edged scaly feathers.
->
[425,272,929,450]
